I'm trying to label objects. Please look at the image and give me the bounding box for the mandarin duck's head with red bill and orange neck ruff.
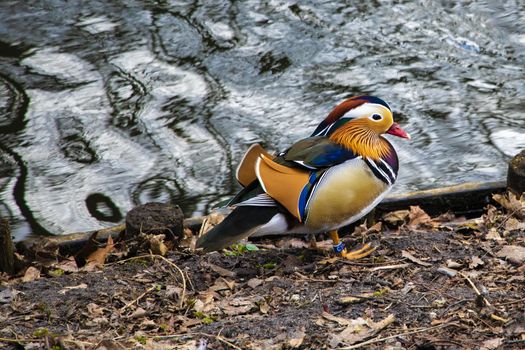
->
[312,96,410,159]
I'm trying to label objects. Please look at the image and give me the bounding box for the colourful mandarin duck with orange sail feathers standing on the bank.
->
[196,96,410,259]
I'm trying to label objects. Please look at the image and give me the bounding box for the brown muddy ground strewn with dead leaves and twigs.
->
[0,196,525,350]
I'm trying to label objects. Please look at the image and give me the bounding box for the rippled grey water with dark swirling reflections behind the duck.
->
[0,0,525,239]
